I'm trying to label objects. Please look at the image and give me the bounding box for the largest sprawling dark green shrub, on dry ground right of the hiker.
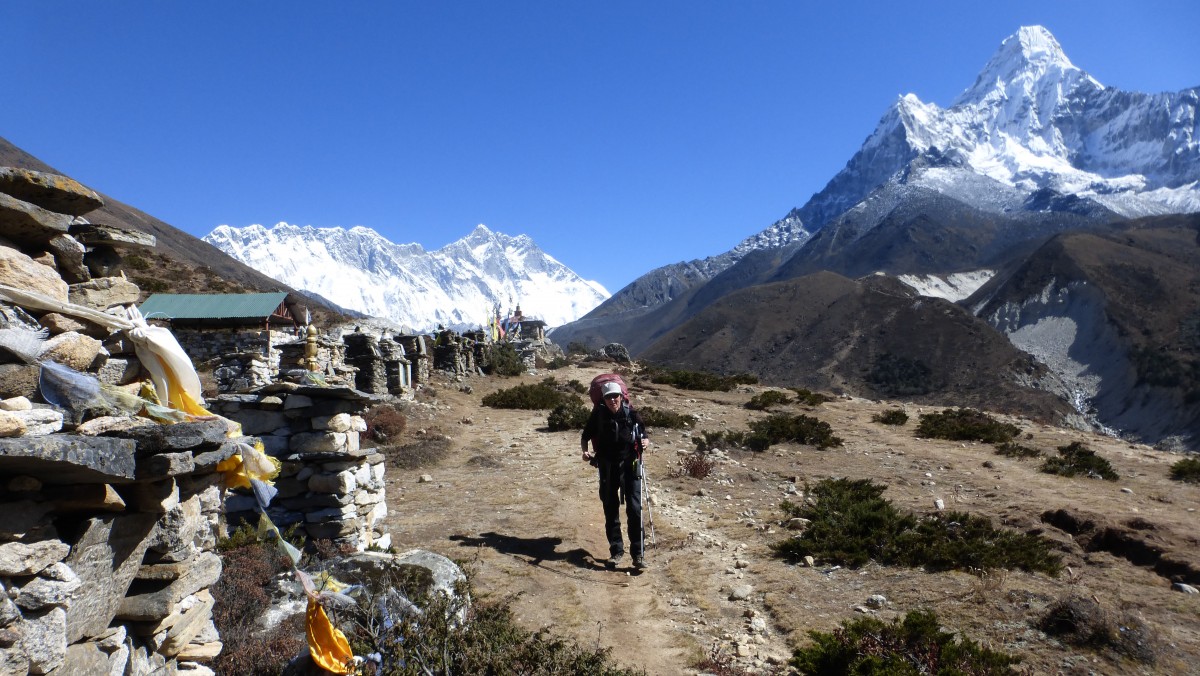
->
[773,479,1062,575]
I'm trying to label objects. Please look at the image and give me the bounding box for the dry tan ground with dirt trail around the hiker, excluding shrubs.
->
[376,366,1200,674]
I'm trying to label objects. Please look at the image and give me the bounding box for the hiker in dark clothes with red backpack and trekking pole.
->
[580,382,649,569]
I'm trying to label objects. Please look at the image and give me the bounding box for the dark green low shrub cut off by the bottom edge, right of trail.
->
[790,610,1020,676]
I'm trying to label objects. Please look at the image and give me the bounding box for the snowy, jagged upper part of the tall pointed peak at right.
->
[798,26,1200,240]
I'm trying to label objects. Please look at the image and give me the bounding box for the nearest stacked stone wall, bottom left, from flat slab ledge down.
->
[0,415,245,675]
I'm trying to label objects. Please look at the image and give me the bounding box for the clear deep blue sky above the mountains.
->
[0,0,1200,292]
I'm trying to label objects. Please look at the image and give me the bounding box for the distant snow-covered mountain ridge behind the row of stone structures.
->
[204,222,608,330]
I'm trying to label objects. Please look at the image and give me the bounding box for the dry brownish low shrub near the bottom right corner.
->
[1037,596,1157,664]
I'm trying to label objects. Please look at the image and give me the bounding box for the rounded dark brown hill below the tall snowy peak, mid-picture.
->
[641,273,1069,420]
